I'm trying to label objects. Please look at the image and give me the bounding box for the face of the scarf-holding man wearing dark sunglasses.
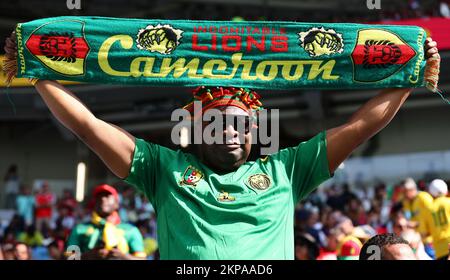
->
[200,106,252,172]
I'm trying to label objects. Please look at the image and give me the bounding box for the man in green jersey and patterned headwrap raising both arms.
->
[5,32,439,259]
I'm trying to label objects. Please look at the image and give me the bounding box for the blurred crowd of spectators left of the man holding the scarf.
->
[0,166,158,260]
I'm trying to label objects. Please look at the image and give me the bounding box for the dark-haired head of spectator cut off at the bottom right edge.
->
[359,233,417,260]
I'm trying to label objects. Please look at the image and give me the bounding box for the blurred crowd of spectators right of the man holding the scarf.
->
[295,178,450,260]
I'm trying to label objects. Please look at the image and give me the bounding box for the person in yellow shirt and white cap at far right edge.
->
[426,179,450,260]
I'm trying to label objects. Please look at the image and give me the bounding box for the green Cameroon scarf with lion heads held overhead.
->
[7,17,426,89]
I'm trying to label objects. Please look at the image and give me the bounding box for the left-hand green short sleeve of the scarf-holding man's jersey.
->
[124,138,159,202]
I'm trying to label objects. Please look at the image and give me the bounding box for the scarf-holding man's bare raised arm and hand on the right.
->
[327,38,439,173]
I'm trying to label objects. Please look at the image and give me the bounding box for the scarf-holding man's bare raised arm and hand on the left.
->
[5,32,135,178]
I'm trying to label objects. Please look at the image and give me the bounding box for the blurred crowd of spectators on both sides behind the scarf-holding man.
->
[0,162,450,260]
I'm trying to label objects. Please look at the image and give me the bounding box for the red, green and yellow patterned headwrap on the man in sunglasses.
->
[183,86,263,117]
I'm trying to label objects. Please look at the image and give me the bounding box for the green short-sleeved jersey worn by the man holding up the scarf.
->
[125,132,330,260]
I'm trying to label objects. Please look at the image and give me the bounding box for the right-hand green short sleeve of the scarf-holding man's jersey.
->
[276,131,331,202]
